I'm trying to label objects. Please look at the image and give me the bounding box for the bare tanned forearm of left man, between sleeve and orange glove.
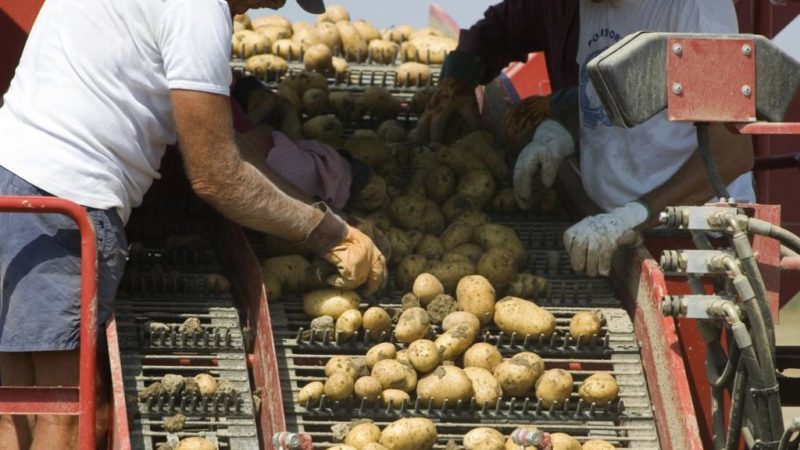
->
[171,90,323,242]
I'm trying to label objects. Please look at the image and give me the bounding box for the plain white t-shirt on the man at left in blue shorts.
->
[0,0,231,220]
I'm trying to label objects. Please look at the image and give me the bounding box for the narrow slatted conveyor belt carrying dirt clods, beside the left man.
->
[116,205,259,450]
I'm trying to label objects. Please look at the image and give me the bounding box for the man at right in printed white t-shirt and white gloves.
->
[514,0,755,276]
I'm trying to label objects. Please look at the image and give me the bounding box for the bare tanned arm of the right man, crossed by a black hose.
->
[642,124,753,226]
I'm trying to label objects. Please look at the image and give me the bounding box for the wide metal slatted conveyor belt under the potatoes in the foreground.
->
[255,219,660,449]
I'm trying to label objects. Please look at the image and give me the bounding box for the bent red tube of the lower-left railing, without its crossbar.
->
[0,196,97,450]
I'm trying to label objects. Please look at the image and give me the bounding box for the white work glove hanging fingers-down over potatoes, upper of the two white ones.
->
[514,120,575,210]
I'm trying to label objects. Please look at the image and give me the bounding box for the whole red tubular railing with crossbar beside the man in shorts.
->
[0,196,97,450]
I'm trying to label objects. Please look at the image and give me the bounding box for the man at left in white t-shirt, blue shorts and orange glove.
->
[0,0,386,450]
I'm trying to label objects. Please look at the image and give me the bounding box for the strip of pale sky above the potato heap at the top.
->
[248,0,488,28]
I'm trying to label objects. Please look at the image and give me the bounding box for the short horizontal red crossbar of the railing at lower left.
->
[0,386,79,416]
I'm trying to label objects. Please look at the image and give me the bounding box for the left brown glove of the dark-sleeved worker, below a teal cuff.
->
[412,78,480,142]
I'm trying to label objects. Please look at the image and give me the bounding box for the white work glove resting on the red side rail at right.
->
[564,202,649,277]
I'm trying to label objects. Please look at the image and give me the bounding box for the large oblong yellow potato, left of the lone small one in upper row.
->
[494,296,556,339]
